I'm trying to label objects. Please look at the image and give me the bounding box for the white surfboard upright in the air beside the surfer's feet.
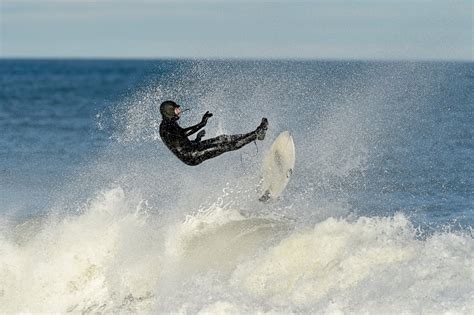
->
[259,131,295,202]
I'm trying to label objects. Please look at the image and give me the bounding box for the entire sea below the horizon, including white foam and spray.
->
[0,59,474,314]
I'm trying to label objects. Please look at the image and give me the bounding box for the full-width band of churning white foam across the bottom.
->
[0,188,474,314]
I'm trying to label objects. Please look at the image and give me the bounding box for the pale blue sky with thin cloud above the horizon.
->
[0,0,473,60]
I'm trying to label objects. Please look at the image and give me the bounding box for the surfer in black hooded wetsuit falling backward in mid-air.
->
[160,101,268,166]
